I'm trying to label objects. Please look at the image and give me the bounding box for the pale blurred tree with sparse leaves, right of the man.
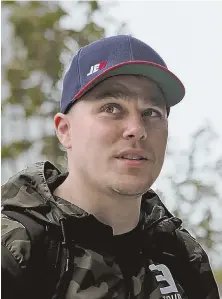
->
[157,124,222,267]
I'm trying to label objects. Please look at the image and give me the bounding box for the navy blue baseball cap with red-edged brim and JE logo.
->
[61,35,185,113]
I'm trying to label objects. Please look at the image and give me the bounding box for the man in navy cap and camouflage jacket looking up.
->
[2,35,219,299]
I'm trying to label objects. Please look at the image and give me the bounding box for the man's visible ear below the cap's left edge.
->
[54,113,72,149]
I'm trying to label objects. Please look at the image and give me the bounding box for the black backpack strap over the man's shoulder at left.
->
[2,210,60,299]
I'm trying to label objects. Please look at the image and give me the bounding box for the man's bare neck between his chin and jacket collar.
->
[54,176,141,235]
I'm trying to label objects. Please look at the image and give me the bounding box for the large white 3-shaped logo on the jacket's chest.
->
[149,264,178,295]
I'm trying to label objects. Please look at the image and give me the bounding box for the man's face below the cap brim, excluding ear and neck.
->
[58,75,168,196]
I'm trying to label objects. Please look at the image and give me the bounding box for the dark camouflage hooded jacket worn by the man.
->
[2,162,219,299]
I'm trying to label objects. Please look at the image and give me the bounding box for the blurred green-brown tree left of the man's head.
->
[2,1,122,179]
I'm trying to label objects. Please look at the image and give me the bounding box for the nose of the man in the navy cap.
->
[123,116,147,141]
